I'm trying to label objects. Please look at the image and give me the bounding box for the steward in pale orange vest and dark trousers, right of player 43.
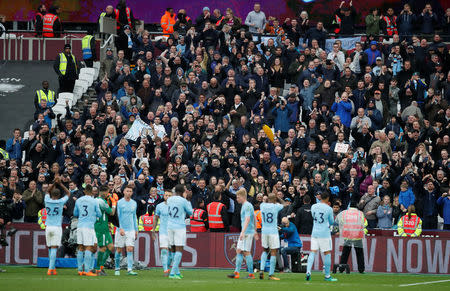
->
[336,202,367,273]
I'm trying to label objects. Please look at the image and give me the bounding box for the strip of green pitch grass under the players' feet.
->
[0,266,450,291]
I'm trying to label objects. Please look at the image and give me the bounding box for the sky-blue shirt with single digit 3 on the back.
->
[73,195,102,229]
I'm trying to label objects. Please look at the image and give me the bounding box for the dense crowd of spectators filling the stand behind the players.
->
[0,4,450,237]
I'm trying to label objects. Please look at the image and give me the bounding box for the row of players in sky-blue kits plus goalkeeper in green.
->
[44,177,336,281]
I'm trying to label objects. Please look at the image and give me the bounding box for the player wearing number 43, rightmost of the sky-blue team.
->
[306,192,337,281]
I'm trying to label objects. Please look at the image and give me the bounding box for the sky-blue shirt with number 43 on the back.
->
[311,202,334,238]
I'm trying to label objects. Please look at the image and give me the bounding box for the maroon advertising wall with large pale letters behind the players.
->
[0,224,450,274]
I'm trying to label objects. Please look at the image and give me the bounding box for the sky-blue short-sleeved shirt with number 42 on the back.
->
[167,196,192,229]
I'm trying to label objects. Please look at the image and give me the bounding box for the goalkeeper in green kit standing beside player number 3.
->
[95,186,118,276]
